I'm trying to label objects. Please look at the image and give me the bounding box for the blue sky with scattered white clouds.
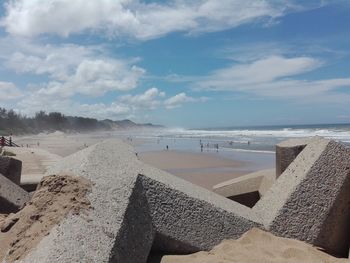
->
[0,0,350,128]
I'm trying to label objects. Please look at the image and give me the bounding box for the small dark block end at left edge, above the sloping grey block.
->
[0,156,22,185]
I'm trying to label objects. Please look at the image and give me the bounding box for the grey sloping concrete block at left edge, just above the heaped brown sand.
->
[0,174,30,214]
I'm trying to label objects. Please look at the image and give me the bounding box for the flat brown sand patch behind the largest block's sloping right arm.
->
[138,151,247,190]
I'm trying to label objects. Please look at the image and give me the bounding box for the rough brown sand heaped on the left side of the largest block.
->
[0,176,90,262]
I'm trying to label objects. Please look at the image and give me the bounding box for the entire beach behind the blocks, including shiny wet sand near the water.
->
[8,131,273,190]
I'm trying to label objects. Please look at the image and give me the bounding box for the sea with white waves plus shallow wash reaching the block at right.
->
[110,124,350,171]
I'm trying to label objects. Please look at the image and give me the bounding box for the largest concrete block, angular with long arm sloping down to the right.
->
[22,140,262,263]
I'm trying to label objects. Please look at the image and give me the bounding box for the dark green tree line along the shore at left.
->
[0,107,116,134]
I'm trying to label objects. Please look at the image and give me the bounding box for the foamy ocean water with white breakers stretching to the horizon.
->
[116,124,350,152]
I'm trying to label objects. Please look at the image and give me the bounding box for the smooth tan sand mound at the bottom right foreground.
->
[158,228,350,263]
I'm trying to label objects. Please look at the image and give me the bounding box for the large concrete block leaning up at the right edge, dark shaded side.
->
[253,138,350,255]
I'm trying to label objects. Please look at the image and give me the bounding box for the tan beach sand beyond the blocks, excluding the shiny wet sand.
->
[13,131,254,190]
